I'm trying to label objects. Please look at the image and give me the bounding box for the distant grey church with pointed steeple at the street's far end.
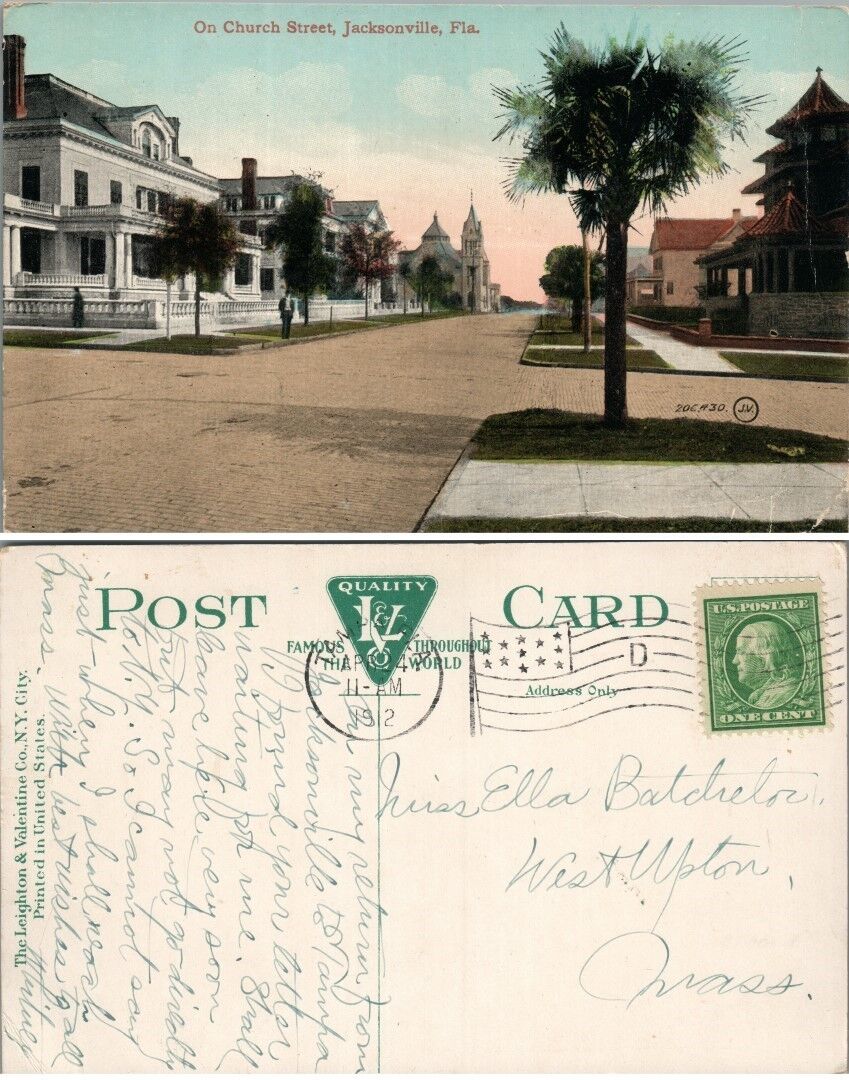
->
[399,202,501,312]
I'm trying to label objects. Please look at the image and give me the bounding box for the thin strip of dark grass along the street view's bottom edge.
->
[422,517,846,532]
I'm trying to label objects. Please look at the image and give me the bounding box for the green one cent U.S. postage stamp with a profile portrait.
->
[700,581,825,731]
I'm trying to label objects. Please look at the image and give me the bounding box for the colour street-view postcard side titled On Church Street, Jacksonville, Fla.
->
[2,0,849,535]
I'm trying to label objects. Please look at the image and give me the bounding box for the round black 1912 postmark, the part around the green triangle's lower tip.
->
[304,634,445,743]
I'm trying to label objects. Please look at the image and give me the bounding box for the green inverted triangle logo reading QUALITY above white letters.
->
[327,573,436,686]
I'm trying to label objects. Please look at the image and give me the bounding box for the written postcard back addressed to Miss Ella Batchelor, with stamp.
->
[0,541,847,1072]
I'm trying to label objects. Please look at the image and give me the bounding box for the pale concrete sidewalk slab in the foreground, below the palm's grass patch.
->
[422,458,849,525]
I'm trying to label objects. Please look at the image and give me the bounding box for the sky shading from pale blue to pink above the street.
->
[4,3,849,296]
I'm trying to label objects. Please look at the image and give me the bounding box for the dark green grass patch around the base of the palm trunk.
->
[471,409,849,462]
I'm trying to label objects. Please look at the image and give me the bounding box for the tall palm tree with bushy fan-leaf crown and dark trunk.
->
[495,25,760,428]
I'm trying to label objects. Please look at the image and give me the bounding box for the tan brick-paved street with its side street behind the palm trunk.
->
[4,315,847,532]
